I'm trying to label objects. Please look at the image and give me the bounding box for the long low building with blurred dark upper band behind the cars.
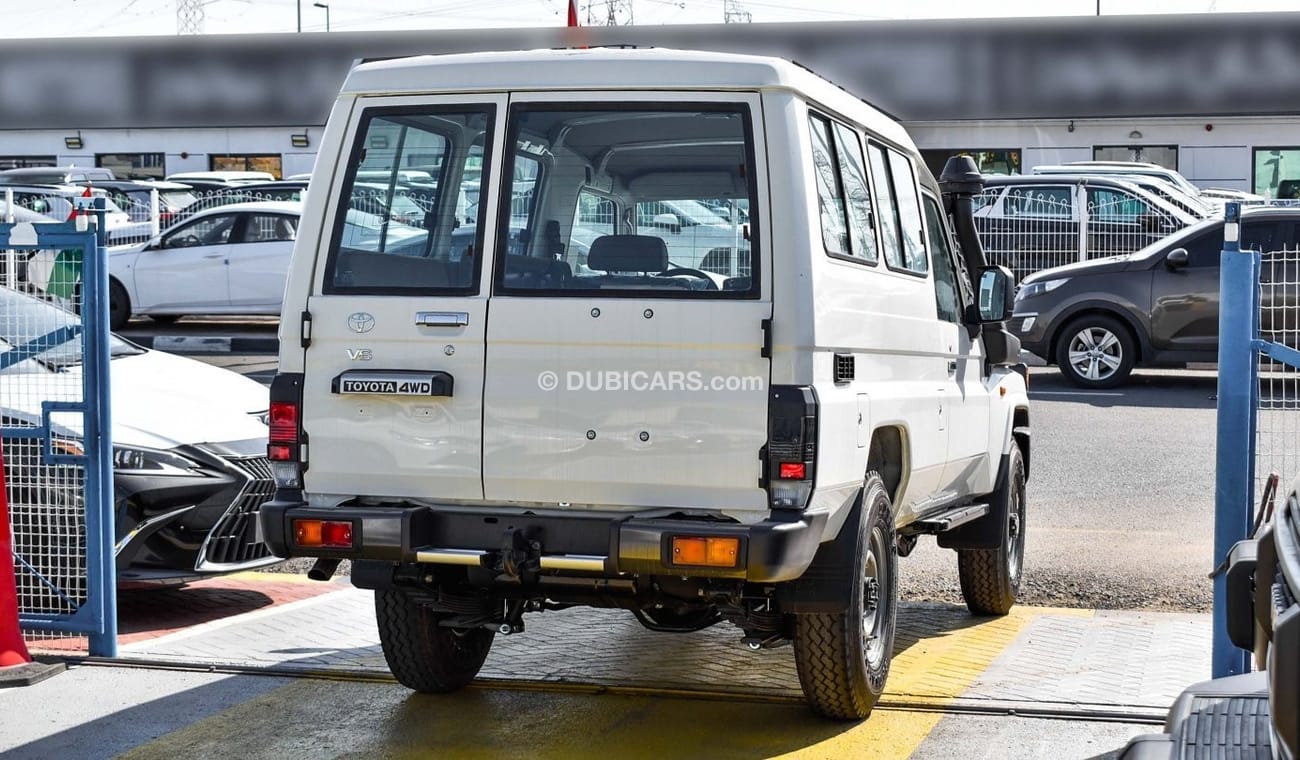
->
[0,13,1300,196]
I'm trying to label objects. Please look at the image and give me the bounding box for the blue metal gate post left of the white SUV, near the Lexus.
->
[82,197,117,657]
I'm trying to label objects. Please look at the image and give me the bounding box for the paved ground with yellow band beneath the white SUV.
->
[0,573,1210,760]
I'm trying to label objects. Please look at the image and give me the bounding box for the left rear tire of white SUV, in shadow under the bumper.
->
[374,589,497,694]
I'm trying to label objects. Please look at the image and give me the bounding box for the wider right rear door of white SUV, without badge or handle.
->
[484,92,772,509]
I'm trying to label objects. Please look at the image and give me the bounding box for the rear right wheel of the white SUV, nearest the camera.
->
[794,473,898,720]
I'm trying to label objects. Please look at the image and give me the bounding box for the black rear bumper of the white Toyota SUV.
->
[260,500,827,583]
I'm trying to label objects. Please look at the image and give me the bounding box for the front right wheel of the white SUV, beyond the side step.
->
[957,442,1026,614]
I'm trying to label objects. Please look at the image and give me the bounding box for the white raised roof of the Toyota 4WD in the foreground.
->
[343,48,913,146]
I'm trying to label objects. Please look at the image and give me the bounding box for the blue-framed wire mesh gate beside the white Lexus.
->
[0,199,117,657]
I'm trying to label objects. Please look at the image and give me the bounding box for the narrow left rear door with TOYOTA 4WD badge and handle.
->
[300,95,506,500]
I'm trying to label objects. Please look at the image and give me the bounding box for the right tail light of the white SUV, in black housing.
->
[764,386,818,509]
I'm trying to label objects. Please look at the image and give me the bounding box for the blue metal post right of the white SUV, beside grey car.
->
[1210,201,1260,678]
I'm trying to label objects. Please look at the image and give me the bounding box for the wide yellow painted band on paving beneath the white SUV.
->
[120,608,1093,760]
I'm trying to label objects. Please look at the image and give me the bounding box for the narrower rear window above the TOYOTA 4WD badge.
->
[325,105,494,294]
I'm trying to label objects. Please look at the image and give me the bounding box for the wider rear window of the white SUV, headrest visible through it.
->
[497,103,758,298]
